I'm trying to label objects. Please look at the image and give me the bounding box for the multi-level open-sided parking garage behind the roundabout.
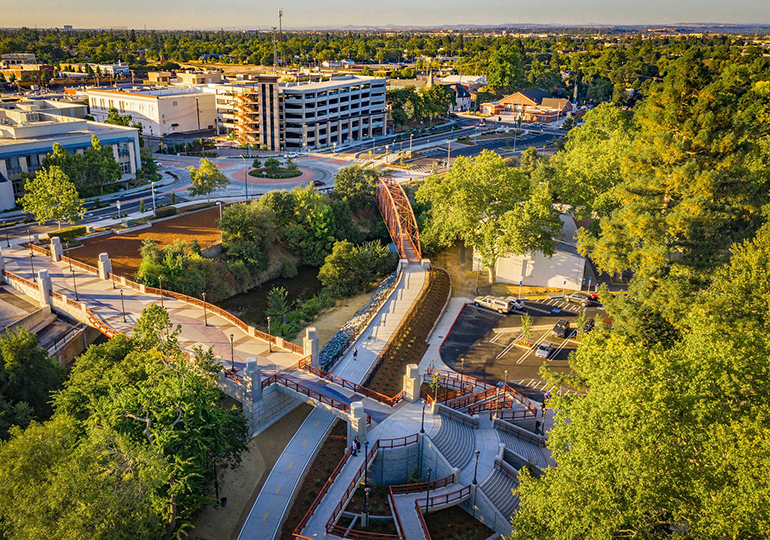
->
[235,75,387,150]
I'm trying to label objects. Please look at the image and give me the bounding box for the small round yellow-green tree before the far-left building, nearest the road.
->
[19,166,86,229]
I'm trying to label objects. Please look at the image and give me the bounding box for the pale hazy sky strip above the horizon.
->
[0,0,770,29]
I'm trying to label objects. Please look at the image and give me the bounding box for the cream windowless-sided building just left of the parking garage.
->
[85,86,216,137]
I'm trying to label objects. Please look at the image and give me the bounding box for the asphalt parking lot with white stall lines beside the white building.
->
[441,298,605,385]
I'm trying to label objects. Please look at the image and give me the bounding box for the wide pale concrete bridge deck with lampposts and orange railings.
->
[2,246,302,375]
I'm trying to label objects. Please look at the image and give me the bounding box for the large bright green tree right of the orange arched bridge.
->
[416,150,561,281]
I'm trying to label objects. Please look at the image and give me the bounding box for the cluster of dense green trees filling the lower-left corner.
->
[0,305,247,540]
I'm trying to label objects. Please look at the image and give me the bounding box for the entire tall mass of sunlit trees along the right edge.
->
[504,37,770,539]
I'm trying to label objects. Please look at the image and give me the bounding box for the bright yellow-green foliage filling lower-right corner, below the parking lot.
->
[511,226,770,539]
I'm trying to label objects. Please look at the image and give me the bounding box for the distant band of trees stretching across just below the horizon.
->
[0,28,762,104]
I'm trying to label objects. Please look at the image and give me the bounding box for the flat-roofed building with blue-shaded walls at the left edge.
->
[0,100,142,209]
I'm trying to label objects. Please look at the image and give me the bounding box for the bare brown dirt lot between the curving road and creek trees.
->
[72,207,219,279]
